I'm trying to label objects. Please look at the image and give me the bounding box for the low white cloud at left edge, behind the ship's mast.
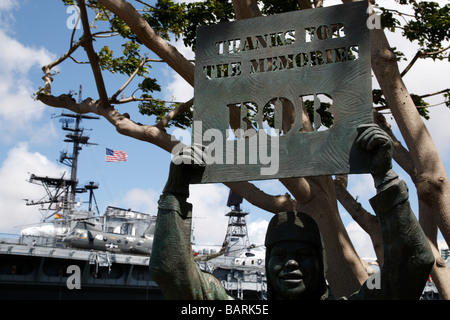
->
[0,143,64,233]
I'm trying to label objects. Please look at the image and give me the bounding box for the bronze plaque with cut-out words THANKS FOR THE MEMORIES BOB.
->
[192,1,373,183]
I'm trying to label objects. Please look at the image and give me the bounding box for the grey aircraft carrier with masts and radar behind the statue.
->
[0,114,266,300]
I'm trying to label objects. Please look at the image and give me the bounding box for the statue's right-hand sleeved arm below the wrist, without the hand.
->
[370,178,434,300]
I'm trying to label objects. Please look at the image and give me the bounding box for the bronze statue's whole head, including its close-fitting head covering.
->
[265,212,328,300]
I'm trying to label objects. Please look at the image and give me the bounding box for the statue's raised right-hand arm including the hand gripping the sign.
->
[357,126,434,299]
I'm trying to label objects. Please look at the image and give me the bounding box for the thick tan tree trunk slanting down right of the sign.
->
[371,29,450,299]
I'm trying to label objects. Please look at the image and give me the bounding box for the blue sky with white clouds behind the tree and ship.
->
[0,0,450,256]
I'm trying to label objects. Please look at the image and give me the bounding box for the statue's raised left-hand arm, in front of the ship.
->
[150,146,232,299]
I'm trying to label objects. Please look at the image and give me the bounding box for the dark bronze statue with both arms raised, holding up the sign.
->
[150,125,434,300]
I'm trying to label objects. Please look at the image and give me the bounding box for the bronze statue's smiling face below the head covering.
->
[267,241,321,299]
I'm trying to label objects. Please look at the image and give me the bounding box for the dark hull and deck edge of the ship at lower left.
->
[0,243,163,300]
